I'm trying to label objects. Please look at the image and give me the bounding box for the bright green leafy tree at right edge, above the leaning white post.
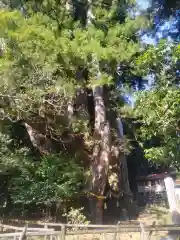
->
[132,43,179,167]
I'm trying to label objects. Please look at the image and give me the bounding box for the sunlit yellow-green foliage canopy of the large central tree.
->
[0,0,148,138]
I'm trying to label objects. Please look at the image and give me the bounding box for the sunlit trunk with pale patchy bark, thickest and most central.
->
[92,86,110,223]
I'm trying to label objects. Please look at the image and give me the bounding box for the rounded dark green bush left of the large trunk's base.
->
[9,154,83,206]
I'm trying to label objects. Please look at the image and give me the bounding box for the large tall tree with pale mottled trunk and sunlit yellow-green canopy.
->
[0,0,148,221]
